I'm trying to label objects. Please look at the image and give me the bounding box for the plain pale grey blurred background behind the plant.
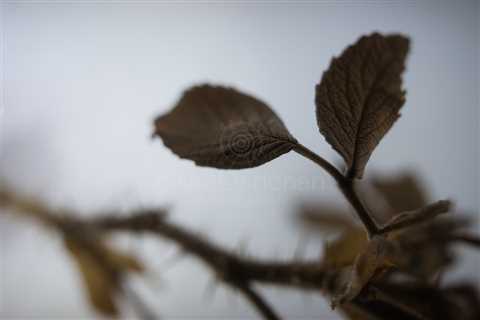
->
[0,1,479,319]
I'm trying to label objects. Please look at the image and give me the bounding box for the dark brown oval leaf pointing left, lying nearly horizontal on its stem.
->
[154,85,297,169]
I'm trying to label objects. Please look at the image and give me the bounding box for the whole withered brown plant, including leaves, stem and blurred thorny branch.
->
[0,33,480,320]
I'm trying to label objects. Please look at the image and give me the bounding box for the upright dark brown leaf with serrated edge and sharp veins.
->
[315,33,409,178]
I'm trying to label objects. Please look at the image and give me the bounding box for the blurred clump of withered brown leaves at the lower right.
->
[298,173,480,320]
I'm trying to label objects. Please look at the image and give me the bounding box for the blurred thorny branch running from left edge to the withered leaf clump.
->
[0,190,334,320]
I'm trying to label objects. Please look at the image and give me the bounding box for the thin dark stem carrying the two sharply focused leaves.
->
[293,144,380,237]
